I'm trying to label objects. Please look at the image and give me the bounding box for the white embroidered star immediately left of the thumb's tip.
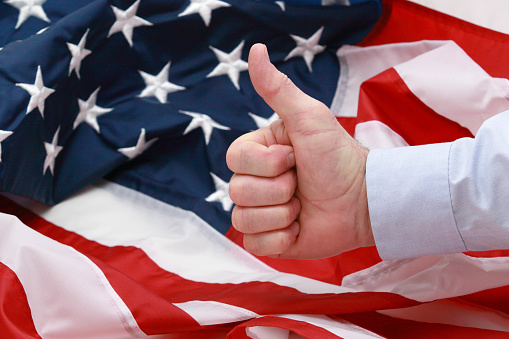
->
[207,41,247,90]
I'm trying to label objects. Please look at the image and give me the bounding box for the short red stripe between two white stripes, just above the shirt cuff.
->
[357,68,473,145]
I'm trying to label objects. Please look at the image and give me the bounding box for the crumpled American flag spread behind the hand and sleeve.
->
[0,0,509,339]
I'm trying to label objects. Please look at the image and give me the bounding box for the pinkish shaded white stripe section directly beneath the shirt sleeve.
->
[342,253,509,302]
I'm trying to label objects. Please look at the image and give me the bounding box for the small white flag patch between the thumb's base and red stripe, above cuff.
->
[355,120,408,149]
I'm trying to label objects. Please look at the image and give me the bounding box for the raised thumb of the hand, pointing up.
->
[248,44,341,146]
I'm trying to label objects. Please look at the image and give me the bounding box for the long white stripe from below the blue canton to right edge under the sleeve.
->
[11,183,509,308]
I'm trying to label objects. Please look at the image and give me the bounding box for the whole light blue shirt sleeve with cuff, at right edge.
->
[366,111,509,260]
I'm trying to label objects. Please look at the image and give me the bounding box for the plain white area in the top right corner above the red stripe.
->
[409,0,509,34]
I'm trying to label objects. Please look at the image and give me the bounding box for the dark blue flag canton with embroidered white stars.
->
[0,0,381,233]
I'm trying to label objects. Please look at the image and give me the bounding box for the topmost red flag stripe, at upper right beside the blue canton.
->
[359,0,509,78]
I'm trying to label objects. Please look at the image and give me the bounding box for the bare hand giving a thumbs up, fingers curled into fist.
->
[226,44,374,259]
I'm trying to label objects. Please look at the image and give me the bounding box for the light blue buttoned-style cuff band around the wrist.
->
[366,143,466,260]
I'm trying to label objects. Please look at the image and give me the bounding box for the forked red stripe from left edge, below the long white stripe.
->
[0,198,418,334]
